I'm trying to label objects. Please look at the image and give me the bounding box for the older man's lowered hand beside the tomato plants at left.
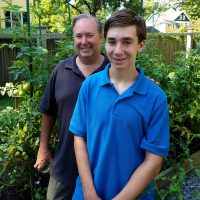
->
[34,148,53,171]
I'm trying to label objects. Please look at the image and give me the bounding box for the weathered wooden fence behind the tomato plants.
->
[0,33,200,86]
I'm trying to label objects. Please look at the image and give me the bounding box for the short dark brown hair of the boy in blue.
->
[104,9,146,43]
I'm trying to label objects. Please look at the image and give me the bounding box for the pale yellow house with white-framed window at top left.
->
[0,0,33,28]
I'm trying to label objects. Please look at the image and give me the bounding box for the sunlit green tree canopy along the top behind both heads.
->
[30,0,200,32]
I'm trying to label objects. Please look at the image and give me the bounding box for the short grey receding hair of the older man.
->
[72,14,102,34]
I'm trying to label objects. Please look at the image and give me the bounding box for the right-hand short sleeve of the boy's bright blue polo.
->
[140,100,170,156]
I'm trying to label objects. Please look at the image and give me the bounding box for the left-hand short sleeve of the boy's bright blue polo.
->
[69,84,87,137]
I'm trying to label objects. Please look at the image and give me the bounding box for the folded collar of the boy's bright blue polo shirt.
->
[100,63,147,95]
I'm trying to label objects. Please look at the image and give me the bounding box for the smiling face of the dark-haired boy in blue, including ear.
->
[106,26,144,68]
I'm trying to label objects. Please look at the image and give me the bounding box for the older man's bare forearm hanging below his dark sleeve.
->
[40,114,56,149]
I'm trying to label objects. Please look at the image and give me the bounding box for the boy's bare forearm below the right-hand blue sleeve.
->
[113,152,163,200]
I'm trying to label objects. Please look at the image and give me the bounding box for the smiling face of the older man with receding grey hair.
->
[73,19,102,59]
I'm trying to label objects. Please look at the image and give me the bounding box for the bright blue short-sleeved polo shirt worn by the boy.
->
[69,65,169,200]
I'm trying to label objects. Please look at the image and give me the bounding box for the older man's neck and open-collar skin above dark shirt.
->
[76,54,104,77]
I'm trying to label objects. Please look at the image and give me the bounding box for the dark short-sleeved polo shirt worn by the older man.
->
[39,55,109,187]
